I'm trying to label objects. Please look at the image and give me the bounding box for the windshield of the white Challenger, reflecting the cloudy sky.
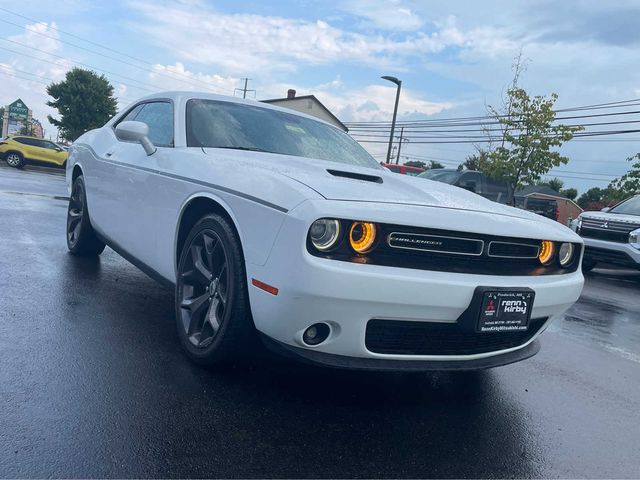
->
[187,99,382,169]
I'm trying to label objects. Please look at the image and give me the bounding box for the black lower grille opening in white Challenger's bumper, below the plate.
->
[365,317,547,355]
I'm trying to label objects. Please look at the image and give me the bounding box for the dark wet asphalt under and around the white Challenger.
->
[0,167,640,478]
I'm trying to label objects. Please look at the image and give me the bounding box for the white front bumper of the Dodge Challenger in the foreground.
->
[247,201,584,369]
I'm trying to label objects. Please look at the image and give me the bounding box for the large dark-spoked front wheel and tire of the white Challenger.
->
[176,214,255,365]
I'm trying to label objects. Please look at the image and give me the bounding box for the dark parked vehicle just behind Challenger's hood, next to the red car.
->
[418,168,511,203]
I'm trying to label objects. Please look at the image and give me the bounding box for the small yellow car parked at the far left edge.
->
[0,135,69,168]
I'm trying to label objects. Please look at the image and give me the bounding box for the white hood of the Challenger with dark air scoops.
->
[203,148,580,241]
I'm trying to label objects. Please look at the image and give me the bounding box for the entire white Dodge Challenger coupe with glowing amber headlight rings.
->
[66,92,584,370]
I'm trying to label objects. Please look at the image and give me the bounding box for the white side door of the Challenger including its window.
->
[105,100,174,268]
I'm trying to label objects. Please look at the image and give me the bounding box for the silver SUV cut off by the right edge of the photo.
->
[573,195,640,271]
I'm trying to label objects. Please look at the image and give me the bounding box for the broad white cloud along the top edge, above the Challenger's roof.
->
[127,0,480,74]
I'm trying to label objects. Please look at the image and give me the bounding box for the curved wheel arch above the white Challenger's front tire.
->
[173,193,244,276]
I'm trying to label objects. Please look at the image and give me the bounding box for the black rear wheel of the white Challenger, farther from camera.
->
[67,175,105,256]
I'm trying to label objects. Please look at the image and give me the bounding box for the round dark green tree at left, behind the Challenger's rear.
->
[47,68,117,142]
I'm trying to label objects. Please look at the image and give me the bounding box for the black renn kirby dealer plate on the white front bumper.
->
[478,291,535,333]
